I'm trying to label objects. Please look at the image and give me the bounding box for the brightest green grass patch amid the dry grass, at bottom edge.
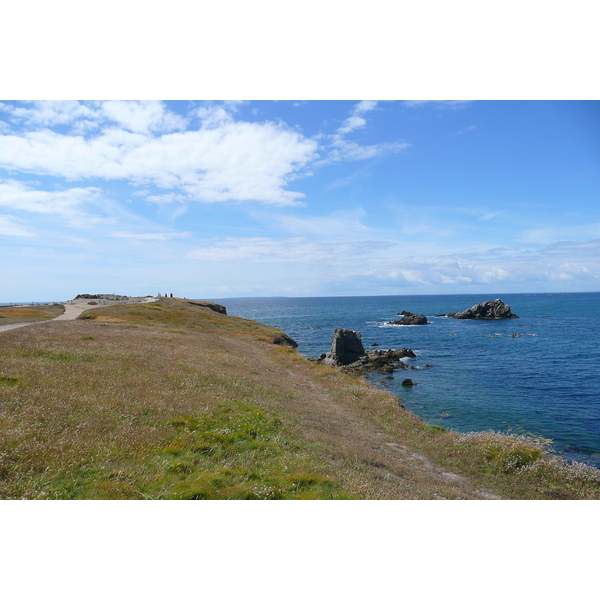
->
[148,402,349,500]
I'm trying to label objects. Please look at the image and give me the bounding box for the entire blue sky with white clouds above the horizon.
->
[0,100,600,302]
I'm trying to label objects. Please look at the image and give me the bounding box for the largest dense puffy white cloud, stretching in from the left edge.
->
[0,122,317,206]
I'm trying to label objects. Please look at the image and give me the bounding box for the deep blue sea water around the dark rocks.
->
[215,293,600,467]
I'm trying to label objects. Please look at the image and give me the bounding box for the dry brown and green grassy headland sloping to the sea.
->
[0,299,600,499]
